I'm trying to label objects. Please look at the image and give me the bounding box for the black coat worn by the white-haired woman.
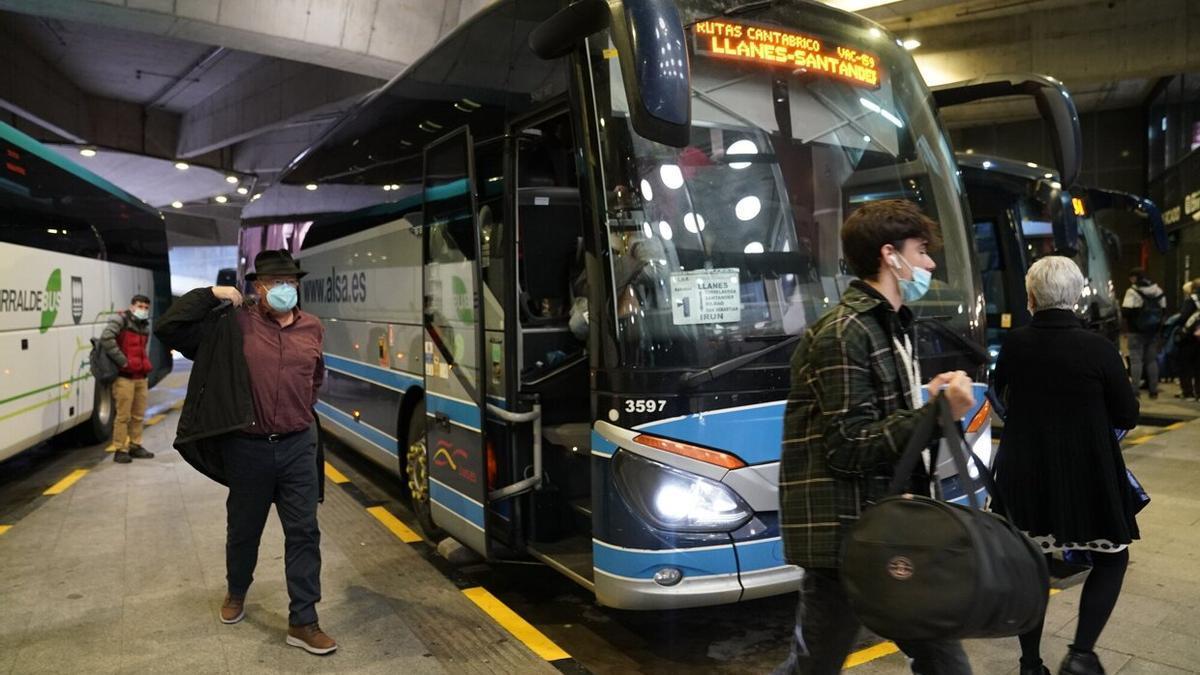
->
[995,310,1139,544]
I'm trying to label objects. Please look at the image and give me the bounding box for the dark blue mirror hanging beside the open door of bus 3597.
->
[529,0,691,148]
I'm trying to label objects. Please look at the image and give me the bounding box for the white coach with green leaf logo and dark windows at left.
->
[0,123,170,460]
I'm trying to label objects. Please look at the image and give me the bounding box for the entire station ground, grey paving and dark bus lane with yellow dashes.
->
[0,364,1200,675]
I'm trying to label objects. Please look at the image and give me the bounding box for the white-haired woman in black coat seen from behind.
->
[995,256,1138,675]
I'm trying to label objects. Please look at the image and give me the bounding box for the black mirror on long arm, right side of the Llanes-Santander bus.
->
[932,73,1084,186]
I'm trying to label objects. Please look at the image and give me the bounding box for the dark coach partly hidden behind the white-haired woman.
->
[958,154,1134,357]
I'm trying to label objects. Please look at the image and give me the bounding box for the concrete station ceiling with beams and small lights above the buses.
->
[0,0,1200,241]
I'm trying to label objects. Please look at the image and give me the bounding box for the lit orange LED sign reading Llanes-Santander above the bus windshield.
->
[692,19,880,89]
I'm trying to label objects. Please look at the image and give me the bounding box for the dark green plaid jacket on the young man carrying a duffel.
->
[779,281,924,568]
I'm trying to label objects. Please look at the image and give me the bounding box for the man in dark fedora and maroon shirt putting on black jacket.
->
[155,250,337,655]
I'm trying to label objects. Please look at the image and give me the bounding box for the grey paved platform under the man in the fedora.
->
[0,367,557,675]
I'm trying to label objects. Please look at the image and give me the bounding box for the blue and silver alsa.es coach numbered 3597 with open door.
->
[242,0,1078,609]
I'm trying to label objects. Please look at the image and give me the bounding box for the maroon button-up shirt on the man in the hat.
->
[238,307,325,435]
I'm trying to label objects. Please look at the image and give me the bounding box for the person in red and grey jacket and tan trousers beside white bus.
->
[100,294,154,464]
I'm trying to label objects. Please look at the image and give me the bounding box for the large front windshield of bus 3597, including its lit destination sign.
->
[596,5,980,368]
